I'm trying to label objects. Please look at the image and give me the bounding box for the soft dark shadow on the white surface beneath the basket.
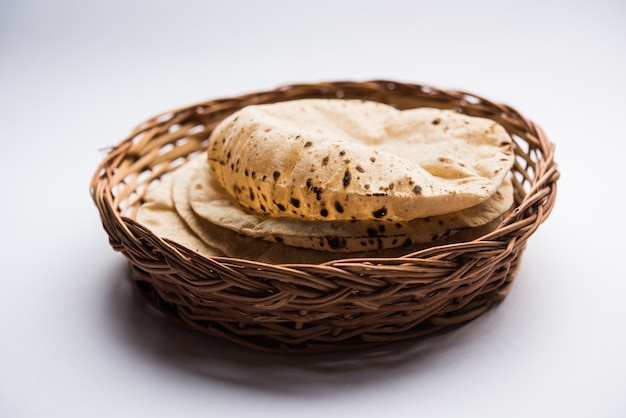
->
[108,263,488,396]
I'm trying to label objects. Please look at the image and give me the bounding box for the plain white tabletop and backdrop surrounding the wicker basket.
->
[0,0,626,418]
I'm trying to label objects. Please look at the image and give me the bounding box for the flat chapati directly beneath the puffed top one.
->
[184,153,513,252]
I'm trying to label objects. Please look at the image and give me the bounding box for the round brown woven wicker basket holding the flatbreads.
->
[90,81,559,353]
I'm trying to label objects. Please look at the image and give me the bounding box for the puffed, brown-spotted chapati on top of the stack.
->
[208,99,515,221]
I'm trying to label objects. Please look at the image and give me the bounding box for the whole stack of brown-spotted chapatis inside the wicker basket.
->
[137,99,515,263]
